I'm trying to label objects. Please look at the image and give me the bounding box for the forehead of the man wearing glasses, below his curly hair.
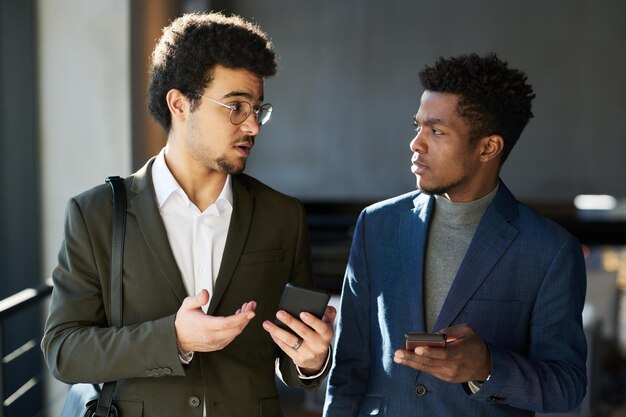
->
[206,65,263,102]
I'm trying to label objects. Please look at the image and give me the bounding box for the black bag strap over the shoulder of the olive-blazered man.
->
[94,176,126,417]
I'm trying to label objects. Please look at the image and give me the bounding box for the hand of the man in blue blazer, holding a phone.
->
[393,324,491,382]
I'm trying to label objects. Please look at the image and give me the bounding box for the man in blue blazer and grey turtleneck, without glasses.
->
[324,54,587,417]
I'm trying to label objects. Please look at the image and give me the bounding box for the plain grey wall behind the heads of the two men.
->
[224,0,626,202]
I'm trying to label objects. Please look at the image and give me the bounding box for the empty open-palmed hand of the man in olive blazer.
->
[174,290,256,352]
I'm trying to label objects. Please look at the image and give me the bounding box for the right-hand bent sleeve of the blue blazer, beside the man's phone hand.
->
[474,232,587,413]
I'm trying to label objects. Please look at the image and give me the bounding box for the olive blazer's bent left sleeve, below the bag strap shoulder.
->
[41,199,185,383]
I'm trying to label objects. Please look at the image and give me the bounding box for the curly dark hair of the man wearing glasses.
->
[148,13,277,132]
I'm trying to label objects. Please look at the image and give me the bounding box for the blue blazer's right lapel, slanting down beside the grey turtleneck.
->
[435,182,519,329]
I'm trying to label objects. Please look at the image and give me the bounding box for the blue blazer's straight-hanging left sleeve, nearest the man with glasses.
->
[324,211,370,417]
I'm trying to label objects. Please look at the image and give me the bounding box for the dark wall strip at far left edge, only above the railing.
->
[0,0,42,298]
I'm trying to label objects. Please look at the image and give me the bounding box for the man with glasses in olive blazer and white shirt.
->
[42,13,335,417]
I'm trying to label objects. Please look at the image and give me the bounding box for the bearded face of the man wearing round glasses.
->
[185,65,263,174]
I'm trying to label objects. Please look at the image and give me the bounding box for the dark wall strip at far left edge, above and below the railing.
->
[0,0,45,417]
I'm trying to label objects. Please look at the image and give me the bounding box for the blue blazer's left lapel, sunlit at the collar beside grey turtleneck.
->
[402,193,434,332]
